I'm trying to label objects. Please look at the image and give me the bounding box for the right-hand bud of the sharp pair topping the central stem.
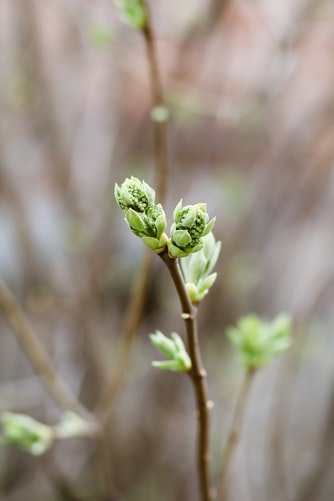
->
[168,200,215,257]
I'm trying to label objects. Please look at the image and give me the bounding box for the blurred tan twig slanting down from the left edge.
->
[0,279,92,420]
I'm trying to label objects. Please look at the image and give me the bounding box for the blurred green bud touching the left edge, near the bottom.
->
[1,412,55,456]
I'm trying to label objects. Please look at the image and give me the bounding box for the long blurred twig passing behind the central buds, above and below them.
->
[97,1,168,421]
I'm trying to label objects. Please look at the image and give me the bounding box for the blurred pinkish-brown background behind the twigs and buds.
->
[0,0,334,501]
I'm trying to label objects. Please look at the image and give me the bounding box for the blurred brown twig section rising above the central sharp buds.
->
[142,4,168,203]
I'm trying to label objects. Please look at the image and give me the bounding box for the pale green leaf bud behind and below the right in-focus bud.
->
[181,232,221,304]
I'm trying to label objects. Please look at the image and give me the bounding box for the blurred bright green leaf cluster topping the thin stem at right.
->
[228,314,291,370]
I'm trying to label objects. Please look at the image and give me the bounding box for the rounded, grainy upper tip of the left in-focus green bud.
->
[115,176,155,212]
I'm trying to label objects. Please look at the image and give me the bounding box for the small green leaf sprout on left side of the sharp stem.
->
[150,330,191,372]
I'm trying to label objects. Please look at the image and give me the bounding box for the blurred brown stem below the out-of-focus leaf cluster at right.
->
[220,370,255,501]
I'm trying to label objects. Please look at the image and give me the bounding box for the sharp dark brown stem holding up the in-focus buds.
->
[160,252,213,501]
